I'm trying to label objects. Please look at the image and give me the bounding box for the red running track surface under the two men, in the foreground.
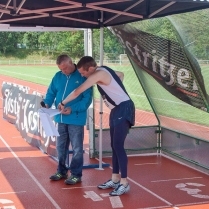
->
[0,74,209,209]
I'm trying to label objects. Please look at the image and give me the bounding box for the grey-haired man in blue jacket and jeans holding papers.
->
[44,54,92,184]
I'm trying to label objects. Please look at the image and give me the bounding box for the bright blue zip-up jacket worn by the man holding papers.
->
[44,68,92,125]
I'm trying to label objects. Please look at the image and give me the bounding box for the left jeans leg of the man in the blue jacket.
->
[56,123,70,175]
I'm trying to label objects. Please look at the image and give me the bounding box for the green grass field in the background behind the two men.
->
[0,65,209,126]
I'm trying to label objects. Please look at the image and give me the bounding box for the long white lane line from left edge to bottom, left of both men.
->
[0,135,61,209]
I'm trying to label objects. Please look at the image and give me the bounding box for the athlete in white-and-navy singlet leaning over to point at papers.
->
[58,56,135,196]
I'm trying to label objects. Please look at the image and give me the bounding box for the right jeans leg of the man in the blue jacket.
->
[68,125,84,178]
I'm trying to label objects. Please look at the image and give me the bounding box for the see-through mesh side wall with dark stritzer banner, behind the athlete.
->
[94,10,209,173]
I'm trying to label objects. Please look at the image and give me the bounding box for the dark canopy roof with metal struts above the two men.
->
[0,0,209,28]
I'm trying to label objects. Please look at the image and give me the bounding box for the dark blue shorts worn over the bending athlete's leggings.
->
[109,100,135,128]
